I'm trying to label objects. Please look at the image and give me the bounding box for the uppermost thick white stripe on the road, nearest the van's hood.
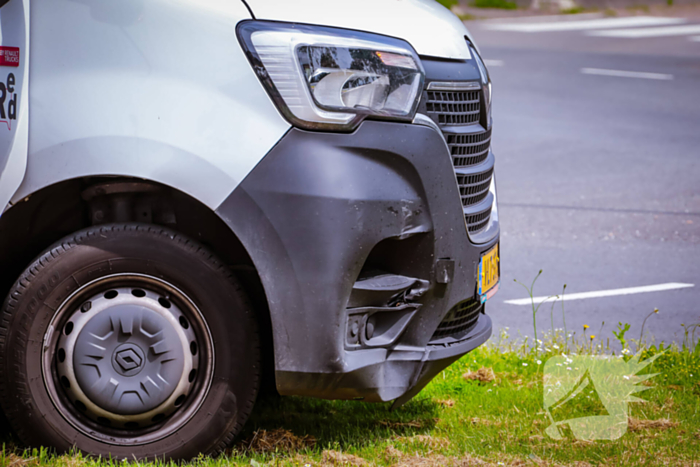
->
[484,16,685,32]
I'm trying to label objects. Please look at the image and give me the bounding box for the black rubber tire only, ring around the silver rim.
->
[0,224,260,460]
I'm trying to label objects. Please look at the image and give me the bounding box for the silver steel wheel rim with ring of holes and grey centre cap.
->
[47,278,212,436]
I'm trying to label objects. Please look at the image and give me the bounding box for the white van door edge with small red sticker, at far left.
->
[0,0,29,215]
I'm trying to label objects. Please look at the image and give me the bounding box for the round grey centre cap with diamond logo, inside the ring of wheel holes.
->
[70,304,189,415]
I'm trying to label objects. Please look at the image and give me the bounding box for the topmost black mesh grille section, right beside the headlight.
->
[426,90,481,125]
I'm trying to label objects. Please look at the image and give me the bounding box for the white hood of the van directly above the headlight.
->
[243,0,471,60]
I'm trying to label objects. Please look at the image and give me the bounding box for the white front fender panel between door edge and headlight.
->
[12,0,290,209]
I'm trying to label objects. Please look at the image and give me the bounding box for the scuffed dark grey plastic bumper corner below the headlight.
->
[217,121,498,401]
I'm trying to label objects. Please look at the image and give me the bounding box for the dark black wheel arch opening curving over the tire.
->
[0,176,274,390]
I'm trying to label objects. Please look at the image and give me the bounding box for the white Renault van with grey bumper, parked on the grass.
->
[0,0,499,459]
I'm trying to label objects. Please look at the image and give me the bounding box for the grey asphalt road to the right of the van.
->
[467,13,700,343]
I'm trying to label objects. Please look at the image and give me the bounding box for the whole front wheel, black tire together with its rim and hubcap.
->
[0,224,260,460]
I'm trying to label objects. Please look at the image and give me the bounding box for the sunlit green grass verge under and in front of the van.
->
[0,333,700,467]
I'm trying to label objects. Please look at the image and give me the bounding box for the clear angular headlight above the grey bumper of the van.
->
[238,21,424,130]
